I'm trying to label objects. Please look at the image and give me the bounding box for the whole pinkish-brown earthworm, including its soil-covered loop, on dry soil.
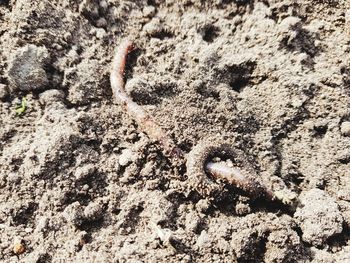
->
[110,40,275,200]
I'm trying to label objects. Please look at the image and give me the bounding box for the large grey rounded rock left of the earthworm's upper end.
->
[7,45,49,91]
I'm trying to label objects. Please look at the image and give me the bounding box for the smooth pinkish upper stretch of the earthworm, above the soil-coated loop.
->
[110,40,183,158]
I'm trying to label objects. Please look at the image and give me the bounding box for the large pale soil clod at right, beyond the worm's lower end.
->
[294,189,344,246]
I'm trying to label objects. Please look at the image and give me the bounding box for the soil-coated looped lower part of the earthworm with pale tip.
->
[186,141,275,200]
